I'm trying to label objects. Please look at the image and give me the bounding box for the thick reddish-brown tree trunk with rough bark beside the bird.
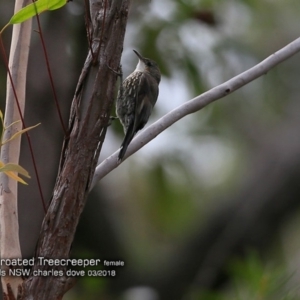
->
[25,0,129,300]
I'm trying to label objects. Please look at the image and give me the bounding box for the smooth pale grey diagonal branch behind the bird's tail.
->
[91,38,300,189]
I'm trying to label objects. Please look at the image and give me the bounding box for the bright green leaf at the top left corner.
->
[9,0,67,24]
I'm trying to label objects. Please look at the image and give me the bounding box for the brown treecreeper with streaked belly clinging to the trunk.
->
[116,50,161,163]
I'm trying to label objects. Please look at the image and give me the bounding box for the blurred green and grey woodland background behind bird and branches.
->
[0,0,300,300]
